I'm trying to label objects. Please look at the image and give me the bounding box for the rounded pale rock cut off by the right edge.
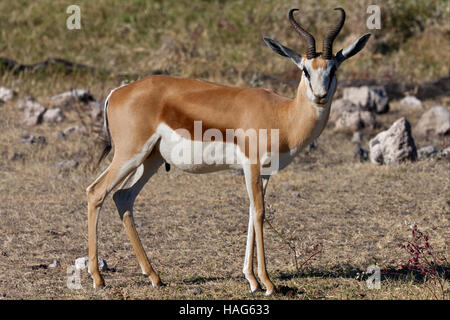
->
[414,106,450,136]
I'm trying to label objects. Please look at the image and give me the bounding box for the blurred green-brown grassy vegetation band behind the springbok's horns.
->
[0,0,450,84]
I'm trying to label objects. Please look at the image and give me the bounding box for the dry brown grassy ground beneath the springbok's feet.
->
[0,88,450,299]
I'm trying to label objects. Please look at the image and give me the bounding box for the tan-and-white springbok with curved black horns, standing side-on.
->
[86,8,370,295]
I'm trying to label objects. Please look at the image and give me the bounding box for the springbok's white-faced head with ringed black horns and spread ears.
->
[264,8,370,106]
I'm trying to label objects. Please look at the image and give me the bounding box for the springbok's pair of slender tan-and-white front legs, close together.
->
[243,164,275,295]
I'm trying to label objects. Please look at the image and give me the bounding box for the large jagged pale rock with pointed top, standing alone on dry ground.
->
[369,118,417,164]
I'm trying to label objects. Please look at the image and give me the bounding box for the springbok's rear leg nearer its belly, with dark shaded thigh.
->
[113,150,164,287]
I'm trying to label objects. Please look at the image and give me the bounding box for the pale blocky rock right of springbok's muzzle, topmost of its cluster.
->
[343,86,389,113]
